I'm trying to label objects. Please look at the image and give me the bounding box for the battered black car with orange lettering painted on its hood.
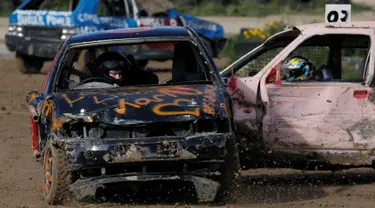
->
[26,26,239,204]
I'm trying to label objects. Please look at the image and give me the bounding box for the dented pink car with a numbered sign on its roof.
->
[221,21,375,170]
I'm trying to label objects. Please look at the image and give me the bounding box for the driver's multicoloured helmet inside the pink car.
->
[281,56,315,81]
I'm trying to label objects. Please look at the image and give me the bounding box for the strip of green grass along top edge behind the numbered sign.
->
[177,0,373,17]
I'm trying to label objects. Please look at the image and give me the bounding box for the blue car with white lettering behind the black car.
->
[5,0,226,73]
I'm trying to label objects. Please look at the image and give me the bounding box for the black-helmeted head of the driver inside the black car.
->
[96,51,132,86]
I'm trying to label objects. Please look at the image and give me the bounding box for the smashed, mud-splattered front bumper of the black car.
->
[58,133,234,202]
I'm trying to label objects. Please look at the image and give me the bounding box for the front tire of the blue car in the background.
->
[16,53,44,74]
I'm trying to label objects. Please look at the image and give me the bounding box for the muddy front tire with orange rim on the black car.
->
[42,141,73,205]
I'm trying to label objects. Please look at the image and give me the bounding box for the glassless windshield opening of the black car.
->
[57,40,212,91]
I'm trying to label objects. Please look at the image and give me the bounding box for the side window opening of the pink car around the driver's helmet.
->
[282,34,371,82]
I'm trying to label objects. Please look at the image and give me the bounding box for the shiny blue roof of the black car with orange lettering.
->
[67,26,194,44]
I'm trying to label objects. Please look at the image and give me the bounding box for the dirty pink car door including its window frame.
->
[259,33,375,152]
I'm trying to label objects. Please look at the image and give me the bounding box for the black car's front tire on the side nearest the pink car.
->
[215,138,241,204]
